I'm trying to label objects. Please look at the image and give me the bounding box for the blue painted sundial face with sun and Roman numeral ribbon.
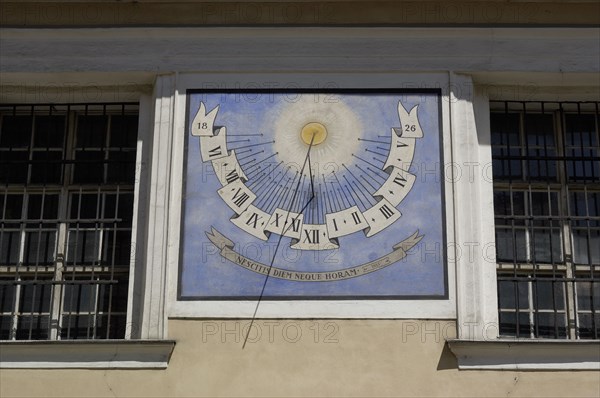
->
[183,92,445,297]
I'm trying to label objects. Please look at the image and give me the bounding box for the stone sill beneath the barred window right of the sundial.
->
[448,339,600,370]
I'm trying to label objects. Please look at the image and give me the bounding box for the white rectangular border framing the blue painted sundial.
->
[165,73,456,319]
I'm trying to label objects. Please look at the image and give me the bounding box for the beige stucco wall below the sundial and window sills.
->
[0,320,600,398]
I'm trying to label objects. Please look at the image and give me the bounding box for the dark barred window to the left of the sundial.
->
[0,103,138,340]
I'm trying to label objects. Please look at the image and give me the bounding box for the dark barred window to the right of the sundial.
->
[490,101,600,339]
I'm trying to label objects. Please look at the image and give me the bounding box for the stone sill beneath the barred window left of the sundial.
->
[0,340,175,369]
